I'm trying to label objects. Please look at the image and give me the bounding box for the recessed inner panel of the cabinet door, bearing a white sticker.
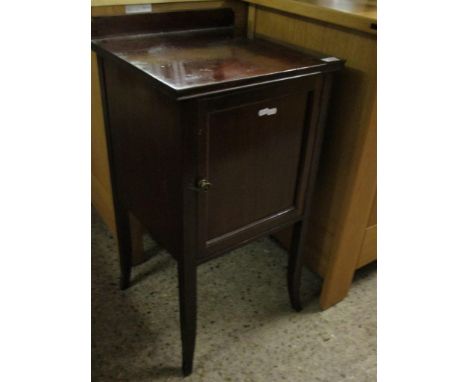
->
[204,92,308,242]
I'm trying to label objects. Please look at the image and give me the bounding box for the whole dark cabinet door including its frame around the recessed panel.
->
[198,81,322,257]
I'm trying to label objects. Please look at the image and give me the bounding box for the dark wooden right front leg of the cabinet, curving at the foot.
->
[288,222,304,312]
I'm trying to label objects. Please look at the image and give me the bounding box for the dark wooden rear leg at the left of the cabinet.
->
[114,205,132,290]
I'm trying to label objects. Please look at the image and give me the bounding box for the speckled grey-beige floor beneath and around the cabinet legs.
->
[92,211,377,382]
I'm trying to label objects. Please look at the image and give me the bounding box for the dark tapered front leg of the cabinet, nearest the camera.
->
[178,261,197,376]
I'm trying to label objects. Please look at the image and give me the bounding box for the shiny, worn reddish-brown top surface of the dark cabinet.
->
[93,29,330,90]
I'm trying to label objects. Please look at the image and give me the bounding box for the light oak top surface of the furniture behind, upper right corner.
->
[243,0,377,34]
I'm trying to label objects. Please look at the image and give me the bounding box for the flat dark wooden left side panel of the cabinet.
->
[104,60,182,255]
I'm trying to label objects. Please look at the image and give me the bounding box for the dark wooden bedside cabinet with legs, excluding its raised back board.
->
[93,10,342,375]
